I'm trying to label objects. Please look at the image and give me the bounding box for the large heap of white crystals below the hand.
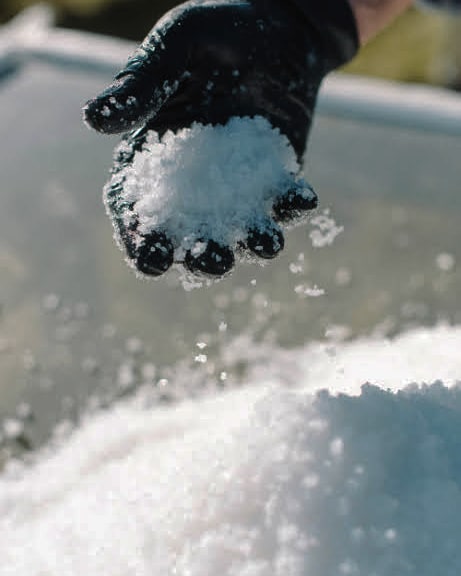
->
[0,327,461,576]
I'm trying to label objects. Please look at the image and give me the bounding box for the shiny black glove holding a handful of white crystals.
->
[84,0,358,276]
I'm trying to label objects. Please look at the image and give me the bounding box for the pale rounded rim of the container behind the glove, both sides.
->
[0,4,461,136]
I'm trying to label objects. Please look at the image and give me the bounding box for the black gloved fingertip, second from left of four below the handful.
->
[184,240,235,276]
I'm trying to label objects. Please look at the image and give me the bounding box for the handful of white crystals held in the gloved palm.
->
[109,117,312,248]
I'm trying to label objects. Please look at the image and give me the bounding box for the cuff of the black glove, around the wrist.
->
[288,0,359,73]
